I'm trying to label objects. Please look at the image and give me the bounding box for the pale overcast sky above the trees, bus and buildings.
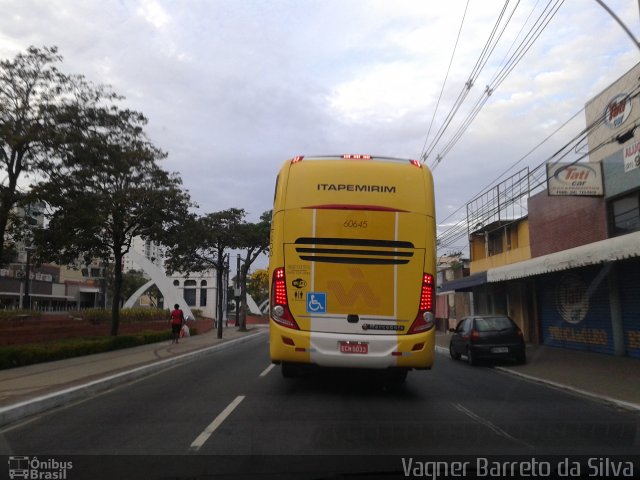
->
[0,0,640,255]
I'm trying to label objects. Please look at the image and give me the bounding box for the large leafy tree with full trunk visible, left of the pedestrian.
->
[35,105,192,336]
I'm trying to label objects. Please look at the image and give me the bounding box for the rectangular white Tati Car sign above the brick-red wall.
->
[547,163,604,196]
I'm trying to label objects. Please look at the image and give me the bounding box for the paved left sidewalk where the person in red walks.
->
[0,325,266,426]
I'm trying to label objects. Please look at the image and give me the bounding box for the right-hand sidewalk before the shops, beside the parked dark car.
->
[436,332,640,411]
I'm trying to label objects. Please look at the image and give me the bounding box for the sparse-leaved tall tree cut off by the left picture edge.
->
[0,47,116,261]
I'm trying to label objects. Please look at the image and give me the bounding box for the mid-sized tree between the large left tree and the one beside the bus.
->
[166,208,246,338]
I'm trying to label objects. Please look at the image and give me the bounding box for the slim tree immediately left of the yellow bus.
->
[238,210,271,331]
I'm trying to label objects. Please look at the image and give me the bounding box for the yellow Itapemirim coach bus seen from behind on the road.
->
[269,155,436,382]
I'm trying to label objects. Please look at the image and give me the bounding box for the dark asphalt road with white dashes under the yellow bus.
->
[0,335,640,478]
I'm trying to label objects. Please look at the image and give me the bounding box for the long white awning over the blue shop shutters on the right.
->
[487,232,640,283]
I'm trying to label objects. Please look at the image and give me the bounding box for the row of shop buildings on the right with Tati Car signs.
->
[444,64,640,358]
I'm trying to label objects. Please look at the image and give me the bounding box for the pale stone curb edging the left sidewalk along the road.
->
[0,331,264,427]
